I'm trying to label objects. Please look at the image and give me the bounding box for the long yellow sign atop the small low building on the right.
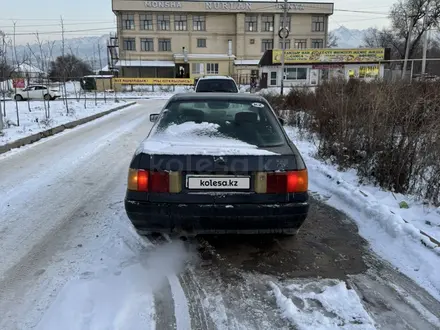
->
[272,48,385,64]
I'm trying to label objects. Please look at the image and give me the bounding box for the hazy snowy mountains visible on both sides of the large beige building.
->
[9,26,368,70]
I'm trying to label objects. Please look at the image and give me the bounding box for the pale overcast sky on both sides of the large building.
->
[0,0,396,44]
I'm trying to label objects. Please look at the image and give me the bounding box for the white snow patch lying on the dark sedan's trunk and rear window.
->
[143,122,276,155]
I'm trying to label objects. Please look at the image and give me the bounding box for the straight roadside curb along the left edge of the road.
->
[0,102,137,154]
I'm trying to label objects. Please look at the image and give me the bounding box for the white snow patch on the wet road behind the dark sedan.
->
[269,281,376,330]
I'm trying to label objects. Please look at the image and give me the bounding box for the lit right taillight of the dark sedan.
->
[266,170,309,194]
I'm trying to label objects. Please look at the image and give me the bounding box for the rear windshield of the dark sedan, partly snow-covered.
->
[155,100,285,147]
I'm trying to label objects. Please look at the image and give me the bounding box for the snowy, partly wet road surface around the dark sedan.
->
[0,100,440,330]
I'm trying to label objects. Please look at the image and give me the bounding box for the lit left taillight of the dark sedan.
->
[127,168,172,193]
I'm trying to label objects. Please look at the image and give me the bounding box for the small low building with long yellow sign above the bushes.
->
[259,48,390,88]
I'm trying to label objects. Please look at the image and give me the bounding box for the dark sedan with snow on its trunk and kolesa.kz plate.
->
[125,93,309,236]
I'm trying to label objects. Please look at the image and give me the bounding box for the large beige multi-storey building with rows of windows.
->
[110,0,333,78]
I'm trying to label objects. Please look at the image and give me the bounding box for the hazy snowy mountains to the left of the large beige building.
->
[9,34,109,70]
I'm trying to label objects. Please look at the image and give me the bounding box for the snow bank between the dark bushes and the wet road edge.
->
[286,128,440,300]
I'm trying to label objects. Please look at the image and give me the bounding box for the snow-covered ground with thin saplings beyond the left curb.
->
[0,100,134,145]
